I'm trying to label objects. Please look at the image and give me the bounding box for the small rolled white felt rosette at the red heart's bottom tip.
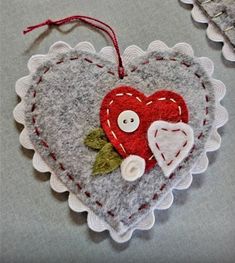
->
[121,155,145,182]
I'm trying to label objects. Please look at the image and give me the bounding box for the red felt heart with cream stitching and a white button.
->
[100,86,188,170]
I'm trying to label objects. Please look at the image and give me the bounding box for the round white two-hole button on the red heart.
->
[117,110,140,132]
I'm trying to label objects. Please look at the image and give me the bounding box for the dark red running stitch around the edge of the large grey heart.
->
[28,56,209,222]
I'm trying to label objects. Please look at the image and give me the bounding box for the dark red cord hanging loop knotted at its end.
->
[23,15,125,79]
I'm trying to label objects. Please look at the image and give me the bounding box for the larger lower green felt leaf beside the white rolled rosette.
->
[93,143,122,175]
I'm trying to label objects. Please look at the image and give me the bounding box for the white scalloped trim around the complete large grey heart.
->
[13,40,228,243]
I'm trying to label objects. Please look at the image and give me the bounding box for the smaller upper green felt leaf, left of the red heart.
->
[84,128,108,150]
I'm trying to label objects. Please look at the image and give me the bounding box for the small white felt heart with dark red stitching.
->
[148,121,194,177]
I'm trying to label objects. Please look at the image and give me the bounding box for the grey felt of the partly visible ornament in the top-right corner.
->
[197,0,235,47]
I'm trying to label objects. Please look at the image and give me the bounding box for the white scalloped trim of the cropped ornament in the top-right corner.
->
[180,0,235,61]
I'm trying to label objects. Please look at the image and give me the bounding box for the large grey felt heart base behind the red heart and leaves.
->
[25,50,215,232]
